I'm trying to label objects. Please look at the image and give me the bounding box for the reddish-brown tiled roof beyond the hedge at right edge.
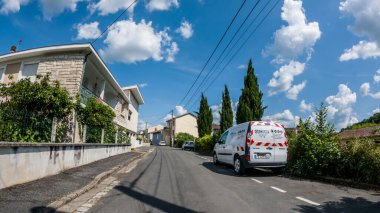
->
[338,125,380,143]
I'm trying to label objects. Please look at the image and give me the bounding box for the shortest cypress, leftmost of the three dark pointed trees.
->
[197,93,212,137]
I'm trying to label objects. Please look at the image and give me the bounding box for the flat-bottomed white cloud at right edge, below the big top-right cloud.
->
[339,41,380,61]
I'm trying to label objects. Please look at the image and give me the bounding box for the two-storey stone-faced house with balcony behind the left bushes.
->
[0,44,144,146]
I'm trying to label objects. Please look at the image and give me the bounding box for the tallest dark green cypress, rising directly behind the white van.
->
[236,60,266,124]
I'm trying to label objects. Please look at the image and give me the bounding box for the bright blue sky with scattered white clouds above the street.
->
[0,0,380,129]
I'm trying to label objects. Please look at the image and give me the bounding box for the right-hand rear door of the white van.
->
[272,123,288,162]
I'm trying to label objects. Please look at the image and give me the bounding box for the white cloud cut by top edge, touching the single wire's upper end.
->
[89,0,137,16]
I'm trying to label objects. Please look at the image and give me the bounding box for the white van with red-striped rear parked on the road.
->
[213,121,288,174]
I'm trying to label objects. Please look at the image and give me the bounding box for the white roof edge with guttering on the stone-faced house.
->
[0,43,131,103]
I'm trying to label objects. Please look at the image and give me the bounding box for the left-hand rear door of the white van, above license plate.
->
[250,122,274,163]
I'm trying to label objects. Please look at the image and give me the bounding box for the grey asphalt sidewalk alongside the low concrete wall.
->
[0,147,149,213]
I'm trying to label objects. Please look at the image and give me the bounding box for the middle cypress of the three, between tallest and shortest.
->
[219,85,234,133]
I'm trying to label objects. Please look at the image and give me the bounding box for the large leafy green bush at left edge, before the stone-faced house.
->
[0,75,74,142]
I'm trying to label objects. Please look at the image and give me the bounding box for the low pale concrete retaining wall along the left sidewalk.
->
[0,143,131,189]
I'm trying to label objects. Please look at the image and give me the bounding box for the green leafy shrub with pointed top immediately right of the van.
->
[288,104,341,176]
